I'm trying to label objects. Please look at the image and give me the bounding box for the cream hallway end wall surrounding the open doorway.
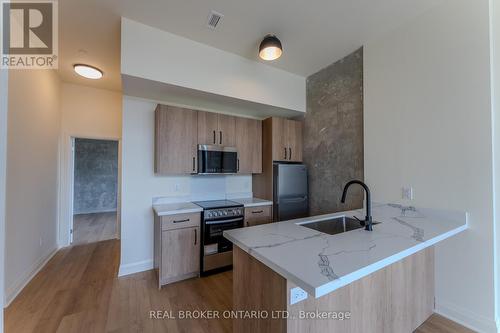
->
[59,83,122,246]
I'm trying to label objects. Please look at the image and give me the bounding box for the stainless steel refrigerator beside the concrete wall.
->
[273,163,309,221]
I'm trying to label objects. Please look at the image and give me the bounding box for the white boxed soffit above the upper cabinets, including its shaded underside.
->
[121,18,306,118]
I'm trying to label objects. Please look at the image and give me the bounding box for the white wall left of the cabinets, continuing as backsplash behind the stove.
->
[120,96,252,275]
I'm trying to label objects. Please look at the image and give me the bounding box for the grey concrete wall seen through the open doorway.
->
[74,139,118,214]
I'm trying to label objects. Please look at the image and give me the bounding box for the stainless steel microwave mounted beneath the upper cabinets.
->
[198,145,238,175]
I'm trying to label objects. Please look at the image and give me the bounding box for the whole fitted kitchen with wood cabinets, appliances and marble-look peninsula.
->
[149,105,467,332]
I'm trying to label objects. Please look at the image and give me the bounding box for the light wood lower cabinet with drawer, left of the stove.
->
[154,214,200,287]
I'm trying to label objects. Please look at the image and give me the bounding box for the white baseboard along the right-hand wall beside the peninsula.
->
[434,301,497,333]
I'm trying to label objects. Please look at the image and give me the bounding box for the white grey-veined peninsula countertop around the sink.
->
[224,204,467,298]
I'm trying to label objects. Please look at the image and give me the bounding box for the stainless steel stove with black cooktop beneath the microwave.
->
[194,200,244,275]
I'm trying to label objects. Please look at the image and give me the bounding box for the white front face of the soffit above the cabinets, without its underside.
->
[121,18,306,112]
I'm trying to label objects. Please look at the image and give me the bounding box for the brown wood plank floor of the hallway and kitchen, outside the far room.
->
[5,240,471,333]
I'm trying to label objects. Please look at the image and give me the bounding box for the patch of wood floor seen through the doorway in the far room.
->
[73,212,116,245]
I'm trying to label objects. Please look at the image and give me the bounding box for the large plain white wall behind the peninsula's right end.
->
[364,0,496,332]
